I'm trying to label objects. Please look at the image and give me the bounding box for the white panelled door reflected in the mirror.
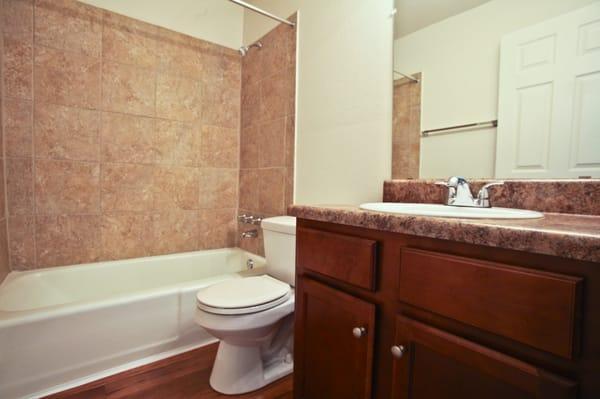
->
[496,2,600,178]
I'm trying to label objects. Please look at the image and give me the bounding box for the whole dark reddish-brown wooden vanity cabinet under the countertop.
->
[294,219,600,399]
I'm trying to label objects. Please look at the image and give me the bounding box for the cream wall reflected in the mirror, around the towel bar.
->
[394,0,593,178]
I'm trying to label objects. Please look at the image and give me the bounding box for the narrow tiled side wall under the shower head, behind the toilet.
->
[239,16,296,255]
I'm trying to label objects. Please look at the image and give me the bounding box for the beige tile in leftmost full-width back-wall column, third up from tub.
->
[34,102,100,161]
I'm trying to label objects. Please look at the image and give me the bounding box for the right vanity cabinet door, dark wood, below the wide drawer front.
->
[392,316,577,399]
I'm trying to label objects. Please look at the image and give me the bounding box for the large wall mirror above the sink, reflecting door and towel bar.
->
[392,0,600,179]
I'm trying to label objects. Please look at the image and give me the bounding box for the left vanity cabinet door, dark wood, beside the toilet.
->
[294,278,375,399]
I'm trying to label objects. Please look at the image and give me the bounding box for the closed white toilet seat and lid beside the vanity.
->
[196,275,291,315]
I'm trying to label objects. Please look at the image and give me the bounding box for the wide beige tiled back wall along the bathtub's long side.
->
[0,0,243,270]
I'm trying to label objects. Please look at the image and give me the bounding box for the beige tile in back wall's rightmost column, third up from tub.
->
[200,126,240,168]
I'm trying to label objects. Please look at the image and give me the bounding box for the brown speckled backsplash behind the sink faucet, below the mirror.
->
[383,179,600,215]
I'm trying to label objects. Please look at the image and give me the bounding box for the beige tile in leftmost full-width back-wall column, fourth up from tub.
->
[34,46,101,109]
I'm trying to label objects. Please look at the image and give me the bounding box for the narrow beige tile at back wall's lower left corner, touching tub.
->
[8,215,35,270]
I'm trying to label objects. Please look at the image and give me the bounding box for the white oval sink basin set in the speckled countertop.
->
[360,202,544,219]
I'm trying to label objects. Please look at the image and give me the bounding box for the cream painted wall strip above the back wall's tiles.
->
[81,0,244,49]
